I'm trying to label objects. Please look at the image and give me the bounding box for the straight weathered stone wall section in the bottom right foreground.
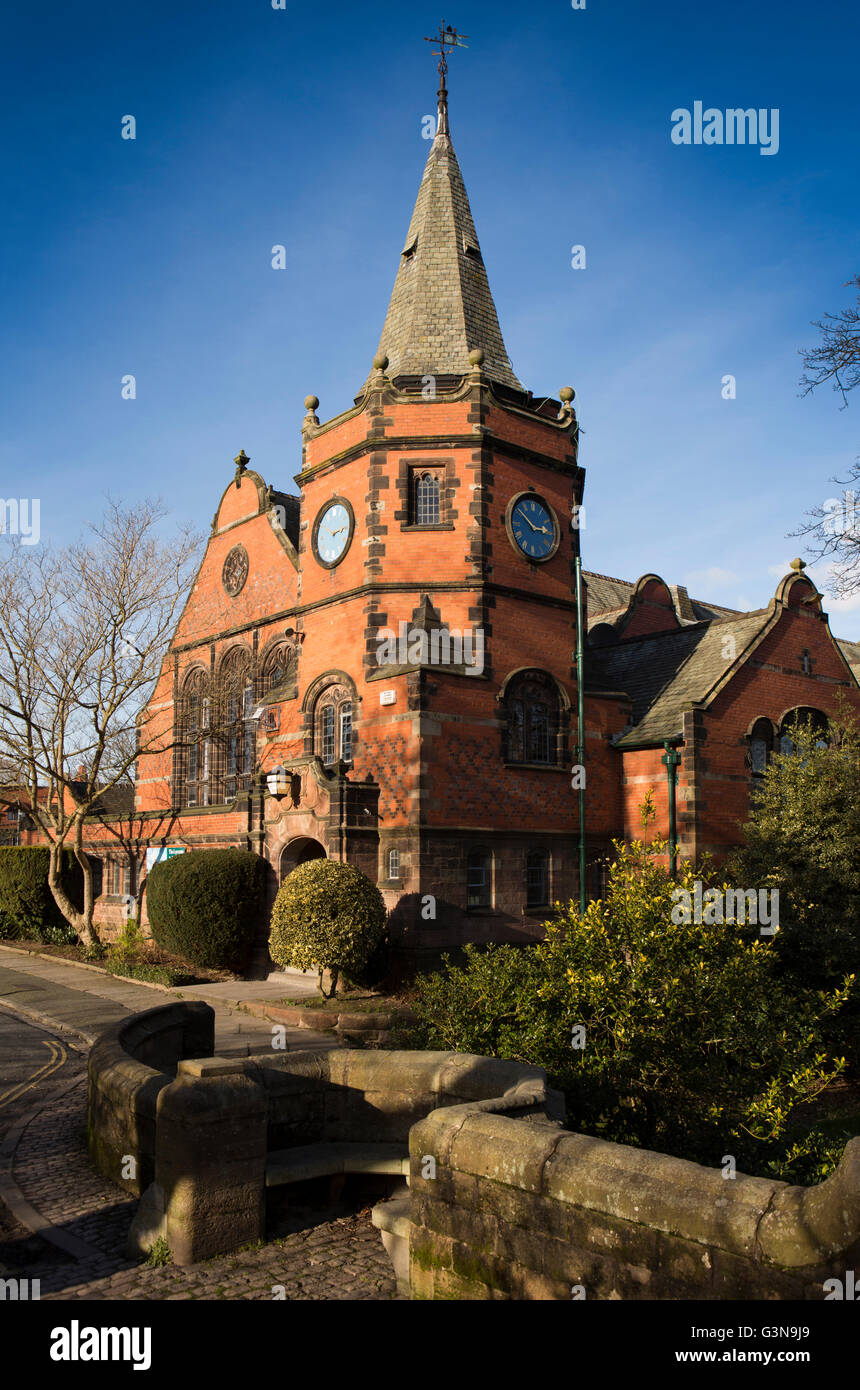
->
[410,1106,860,1300]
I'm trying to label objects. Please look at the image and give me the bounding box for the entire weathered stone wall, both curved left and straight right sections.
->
[89,1004,860,1301]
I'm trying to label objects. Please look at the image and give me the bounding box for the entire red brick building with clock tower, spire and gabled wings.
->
[53,81,860,949]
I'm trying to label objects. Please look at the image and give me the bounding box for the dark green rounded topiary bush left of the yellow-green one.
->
[146,849,265,974]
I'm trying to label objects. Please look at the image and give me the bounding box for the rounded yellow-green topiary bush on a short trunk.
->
[268,859,386,999]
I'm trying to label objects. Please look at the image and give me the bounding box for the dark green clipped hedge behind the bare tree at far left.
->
[0,845,83,945]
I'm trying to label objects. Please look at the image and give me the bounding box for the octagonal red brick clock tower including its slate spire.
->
[286,46,584,952]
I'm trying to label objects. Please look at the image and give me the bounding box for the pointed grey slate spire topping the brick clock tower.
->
[368,75,524,391]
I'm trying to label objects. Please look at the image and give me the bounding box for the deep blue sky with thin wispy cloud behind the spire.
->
[0,0,860,638]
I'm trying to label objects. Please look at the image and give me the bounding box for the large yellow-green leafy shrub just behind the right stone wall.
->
[415,822,853,1182]
